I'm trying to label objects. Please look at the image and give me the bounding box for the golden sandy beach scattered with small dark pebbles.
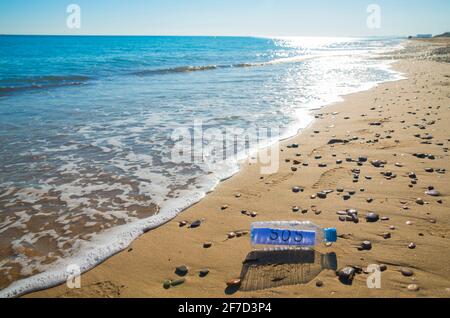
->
[27,40,450,298]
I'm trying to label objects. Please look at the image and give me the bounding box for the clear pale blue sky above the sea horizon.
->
[0,0,450,36]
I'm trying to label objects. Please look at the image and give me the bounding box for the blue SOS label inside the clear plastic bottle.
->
[251,228,316,247]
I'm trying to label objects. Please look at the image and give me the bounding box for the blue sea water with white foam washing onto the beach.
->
[0,36,402,295]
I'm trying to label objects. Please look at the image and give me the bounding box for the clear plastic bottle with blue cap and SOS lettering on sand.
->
[251,221,337,249]
